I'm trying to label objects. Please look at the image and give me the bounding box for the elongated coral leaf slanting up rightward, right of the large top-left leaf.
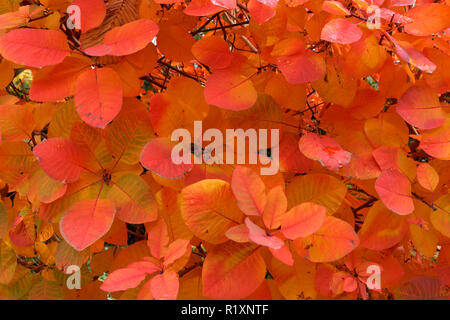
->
[84,19,159,56]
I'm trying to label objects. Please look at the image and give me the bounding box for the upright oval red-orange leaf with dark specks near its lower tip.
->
[74,68,123,129]
